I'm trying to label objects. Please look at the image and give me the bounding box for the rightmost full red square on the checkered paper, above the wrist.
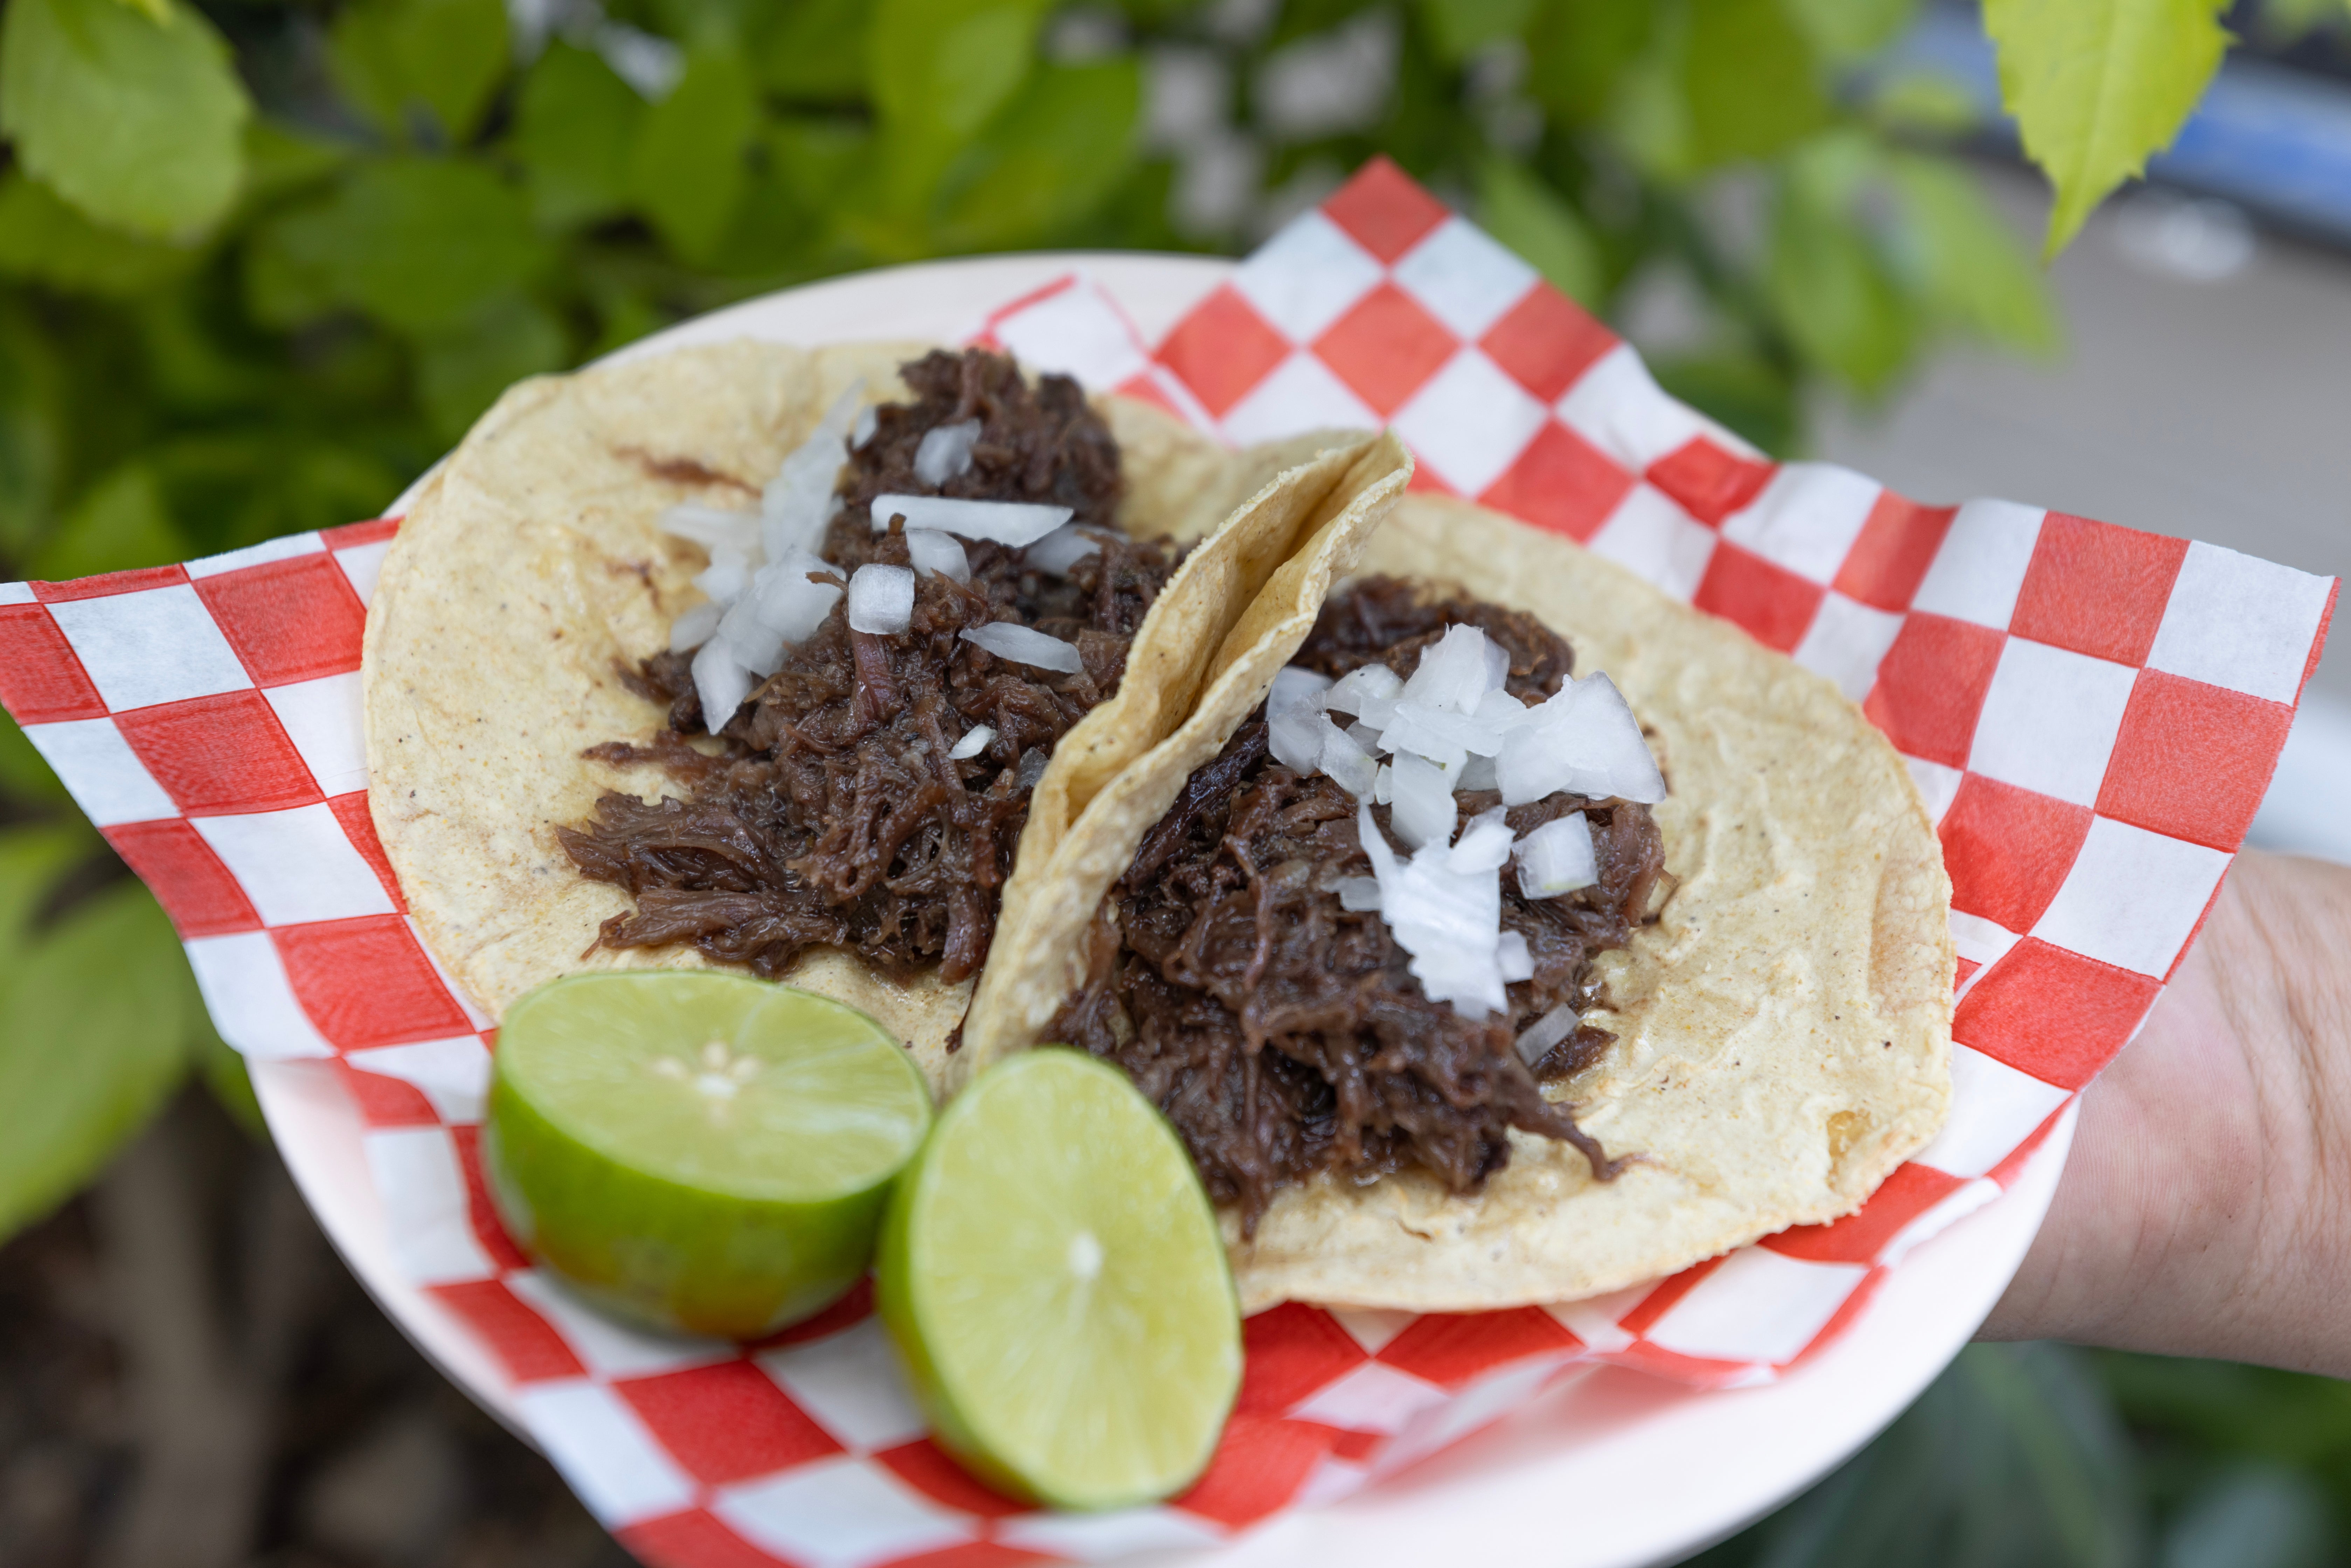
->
[2097,670,2295,851]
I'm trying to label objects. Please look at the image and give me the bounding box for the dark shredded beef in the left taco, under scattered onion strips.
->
[557,350,1178,980]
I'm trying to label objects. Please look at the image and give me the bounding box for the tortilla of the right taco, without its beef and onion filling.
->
[966,496,1954,1312]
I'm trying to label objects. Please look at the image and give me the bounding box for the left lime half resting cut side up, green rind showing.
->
[482,969,931,1340]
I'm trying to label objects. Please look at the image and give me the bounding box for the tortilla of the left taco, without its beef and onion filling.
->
[362,341,1401,1088]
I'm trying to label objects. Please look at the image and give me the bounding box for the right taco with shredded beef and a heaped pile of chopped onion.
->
[957,482,1954,1312]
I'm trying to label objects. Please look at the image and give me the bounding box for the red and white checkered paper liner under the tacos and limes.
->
[0,162,2335,1568]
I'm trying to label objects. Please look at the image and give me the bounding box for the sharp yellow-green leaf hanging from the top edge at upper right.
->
[1984,0,2229,259]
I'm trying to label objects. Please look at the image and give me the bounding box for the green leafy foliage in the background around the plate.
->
[0,0,2351,1566]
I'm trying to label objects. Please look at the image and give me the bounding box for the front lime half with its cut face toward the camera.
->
[875,1048,1241,1509]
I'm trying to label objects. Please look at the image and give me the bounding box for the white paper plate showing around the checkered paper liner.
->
[251,254,2074,1568]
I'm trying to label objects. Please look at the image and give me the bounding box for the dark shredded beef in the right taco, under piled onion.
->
[1051,578,1665,1232]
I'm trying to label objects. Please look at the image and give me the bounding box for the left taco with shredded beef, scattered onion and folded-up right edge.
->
[362,341,1410,1086]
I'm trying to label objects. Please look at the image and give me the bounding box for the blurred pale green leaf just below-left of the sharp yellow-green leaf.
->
[1888,155,2057,355]
